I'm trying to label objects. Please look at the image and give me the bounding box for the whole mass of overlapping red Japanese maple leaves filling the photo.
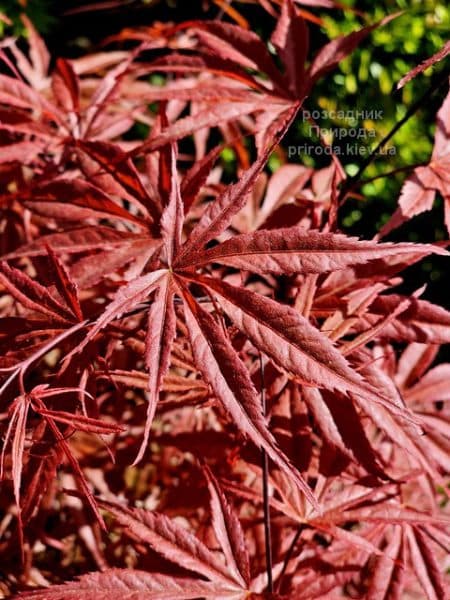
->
[0,1,450,600]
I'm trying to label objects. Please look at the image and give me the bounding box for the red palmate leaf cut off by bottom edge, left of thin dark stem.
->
[21,486,250,600]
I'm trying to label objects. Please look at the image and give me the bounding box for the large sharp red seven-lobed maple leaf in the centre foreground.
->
[60,126,436,501]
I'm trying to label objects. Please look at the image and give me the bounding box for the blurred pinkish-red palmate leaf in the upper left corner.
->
[0,36,146,175]
